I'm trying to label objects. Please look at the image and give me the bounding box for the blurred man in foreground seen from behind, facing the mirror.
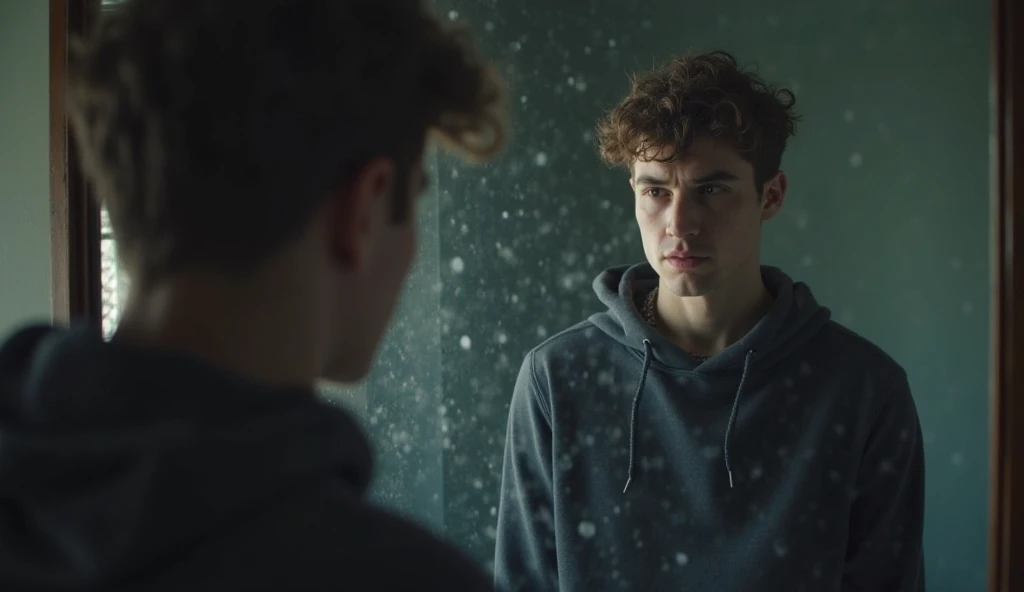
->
[0,0,503,592]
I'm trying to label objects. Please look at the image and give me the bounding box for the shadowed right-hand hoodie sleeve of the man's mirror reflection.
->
[843,370,925,592]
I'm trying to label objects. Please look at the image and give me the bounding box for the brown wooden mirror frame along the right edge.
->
[988,0,1024,592]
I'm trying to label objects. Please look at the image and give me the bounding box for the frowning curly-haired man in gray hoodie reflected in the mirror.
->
[496,52,925,592]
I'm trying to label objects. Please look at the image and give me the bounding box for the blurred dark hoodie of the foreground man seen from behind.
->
[0,326,493,592]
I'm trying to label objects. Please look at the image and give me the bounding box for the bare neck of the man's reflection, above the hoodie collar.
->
[656,267,772,356]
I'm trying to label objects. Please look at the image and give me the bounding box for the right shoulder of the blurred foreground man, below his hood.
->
[172,482,493,591]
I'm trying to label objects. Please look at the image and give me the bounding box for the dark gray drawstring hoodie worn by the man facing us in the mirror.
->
[495,264,925,592]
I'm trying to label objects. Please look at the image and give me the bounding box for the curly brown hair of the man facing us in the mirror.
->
[597,51,799,192]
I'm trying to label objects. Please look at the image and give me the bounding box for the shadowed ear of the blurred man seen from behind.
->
[330,157,396,270]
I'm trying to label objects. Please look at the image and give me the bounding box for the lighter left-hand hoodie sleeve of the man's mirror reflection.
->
[495,351,558,592]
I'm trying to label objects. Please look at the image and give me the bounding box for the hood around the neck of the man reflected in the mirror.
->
[590,263,829,373]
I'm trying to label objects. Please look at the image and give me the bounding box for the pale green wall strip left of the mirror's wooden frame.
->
[0,0,51,334]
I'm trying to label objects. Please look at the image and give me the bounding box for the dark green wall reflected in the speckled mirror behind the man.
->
[346,0,989,592]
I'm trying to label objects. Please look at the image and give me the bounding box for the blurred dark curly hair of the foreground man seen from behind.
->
[69,0,505,278]
